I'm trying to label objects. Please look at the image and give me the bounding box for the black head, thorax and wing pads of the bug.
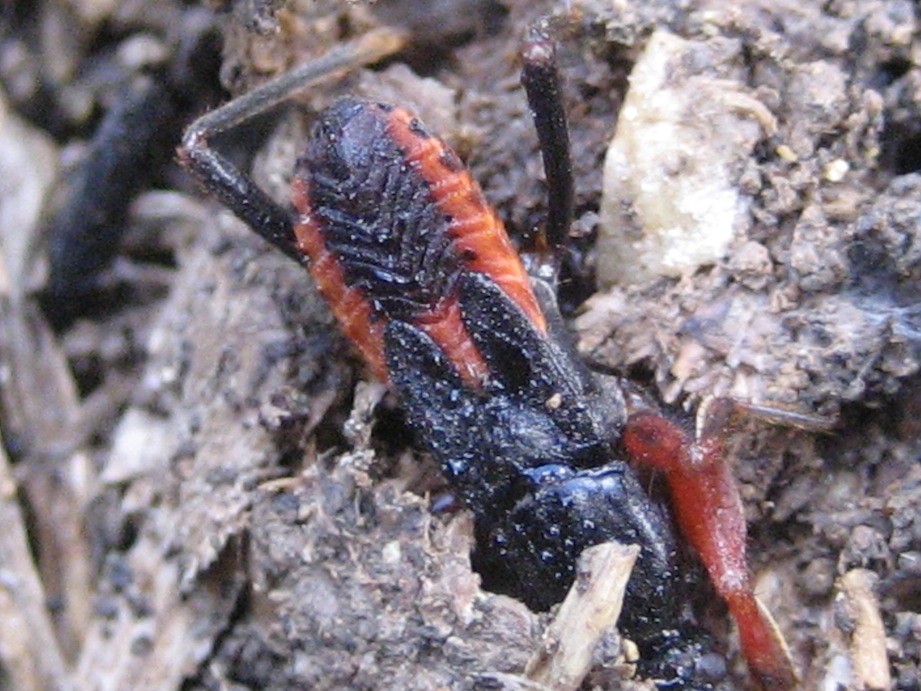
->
[386,274,722,689]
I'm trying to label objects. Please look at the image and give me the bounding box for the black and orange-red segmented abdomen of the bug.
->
[293,99,546,384]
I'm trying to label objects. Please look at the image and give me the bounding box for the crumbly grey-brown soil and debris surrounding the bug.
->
[0,0,921,690]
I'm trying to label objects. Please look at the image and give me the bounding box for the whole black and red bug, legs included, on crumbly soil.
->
[179,24,796,689]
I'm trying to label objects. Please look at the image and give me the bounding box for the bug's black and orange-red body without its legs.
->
[293,94,720,688]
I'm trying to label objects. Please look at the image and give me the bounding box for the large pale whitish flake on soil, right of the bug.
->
[598,31,776,286]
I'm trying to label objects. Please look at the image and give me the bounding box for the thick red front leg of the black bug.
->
[623,411,797,689]
